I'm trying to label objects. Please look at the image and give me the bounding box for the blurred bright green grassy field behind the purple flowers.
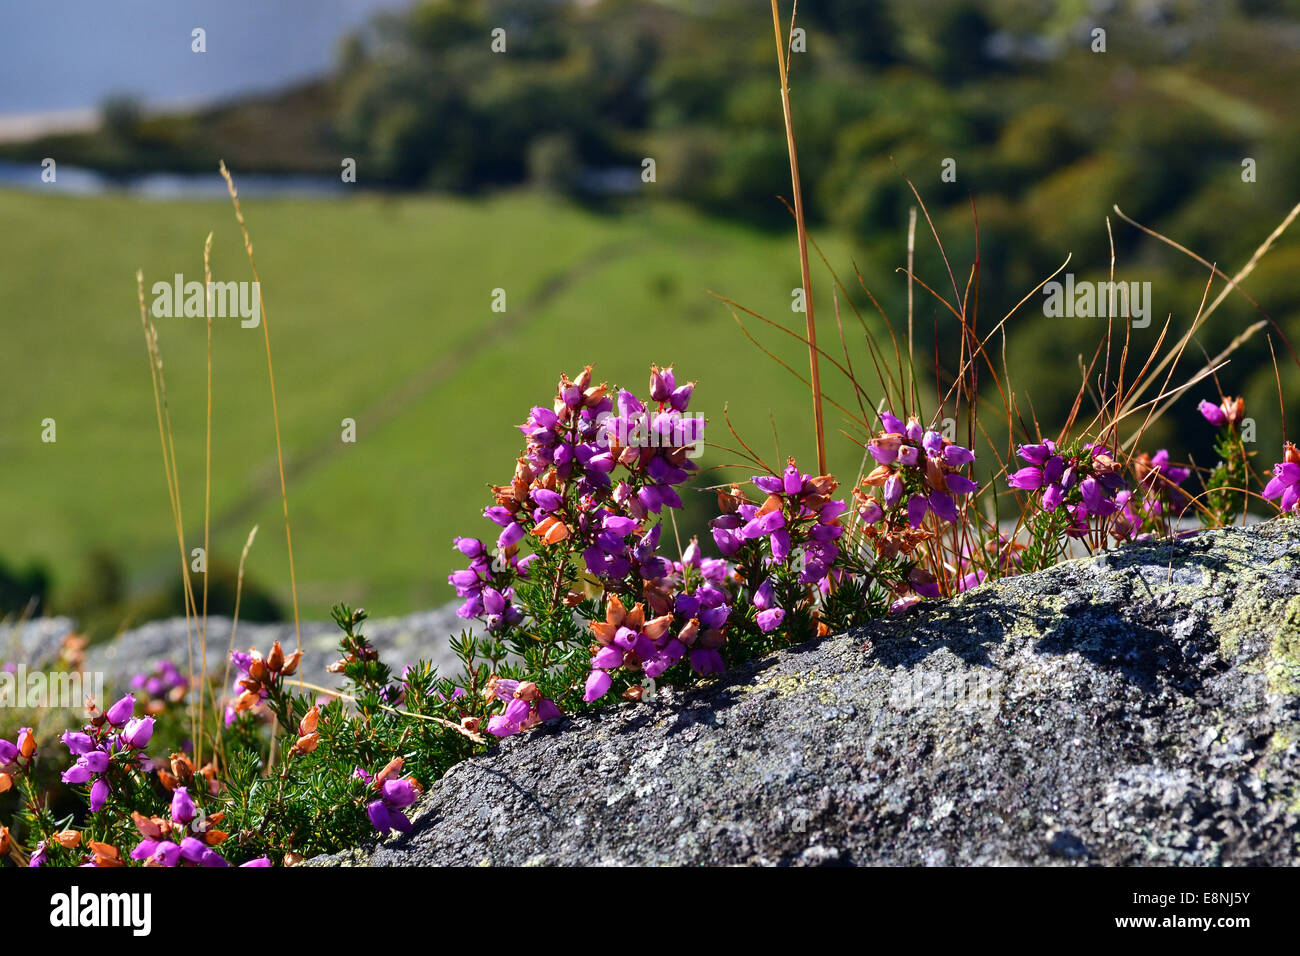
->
[0,193,893,618]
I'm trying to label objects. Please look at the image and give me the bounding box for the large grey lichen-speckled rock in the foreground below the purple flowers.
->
[311,520,1300,865]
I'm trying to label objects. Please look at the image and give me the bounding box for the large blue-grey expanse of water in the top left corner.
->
[0,0,410,120]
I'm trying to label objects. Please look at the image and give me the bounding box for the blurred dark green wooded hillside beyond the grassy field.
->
[335,0,1300,464]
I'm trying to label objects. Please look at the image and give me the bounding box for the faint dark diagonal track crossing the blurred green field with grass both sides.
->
[212,239,641,533]
